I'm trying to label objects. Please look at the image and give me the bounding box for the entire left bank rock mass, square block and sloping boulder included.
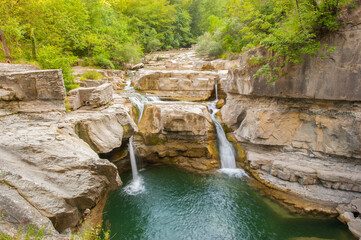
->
[0,65,136,238]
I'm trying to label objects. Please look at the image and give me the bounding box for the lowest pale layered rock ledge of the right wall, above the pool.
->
[247,151,361,196]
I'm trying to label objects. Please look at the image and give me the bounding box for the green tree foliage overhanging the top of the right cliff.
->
[195,0,351,81]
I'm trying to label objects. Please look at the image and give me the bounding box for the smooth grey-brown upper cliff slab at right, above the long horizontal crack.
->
[225,20,361,101]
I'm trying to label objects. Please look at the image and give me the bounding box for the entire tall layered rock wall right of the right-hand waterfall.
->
[221,7,361,218]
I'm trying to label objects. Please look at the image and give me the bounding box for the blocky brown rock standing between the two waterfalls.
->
[134,103,219,171]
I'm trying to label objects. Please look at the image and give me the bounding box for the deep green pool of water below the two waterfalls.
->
[104,166,354,240]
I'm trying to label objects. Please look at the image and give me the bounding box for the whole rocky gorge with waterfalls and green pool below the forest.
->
[0,16,361,240]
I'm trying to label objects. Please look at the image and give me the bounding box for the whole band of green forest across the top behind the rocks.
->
[0,0,356,90]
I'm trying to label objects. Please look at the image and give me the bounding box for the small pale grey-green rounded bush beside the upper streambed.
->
[196,32,223,57]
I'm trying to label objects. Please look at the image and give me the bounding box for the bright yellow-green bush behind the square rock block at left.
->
[37,45,79,91]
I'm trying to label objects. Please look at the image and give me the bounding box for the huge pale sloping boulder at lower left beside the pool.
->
[0,113,121,232]
